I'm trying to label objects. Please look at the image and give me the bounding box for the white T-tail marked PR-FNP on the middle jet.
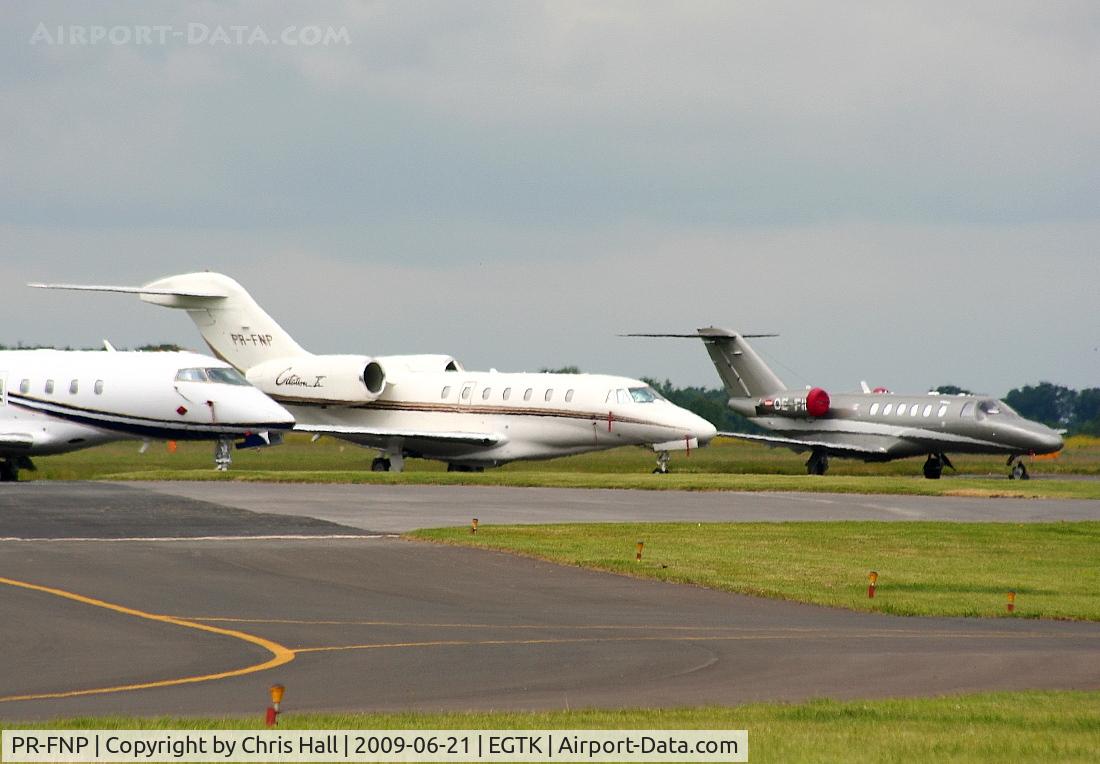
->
[31,272,310,372]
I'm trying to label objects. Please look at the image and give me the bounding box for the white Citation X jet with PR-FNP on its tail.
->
[31,273,716,472]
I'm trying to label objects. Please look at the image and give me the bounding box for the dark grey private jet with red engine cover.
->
[626,326,1063,479]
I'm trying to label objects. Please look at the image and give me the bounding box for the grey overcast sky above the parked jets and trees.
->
[0,0,1100,395]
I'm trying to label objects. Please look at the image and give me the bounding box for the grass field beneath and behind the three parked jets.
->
[15,435,1100,499]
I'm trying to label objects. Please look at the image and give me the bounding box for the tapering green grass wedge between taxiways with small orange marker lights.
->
[406,518,1100,621]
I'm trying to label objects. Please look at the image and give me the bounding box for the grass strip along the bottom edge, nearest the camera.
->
[2,687,1100,764]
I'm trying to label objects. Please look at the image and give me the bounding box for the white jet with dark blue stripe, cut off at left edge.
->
[0,344,294,481]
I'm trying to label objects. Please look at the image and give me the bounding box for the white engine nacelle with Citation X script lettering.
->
[244,355,386,406]
